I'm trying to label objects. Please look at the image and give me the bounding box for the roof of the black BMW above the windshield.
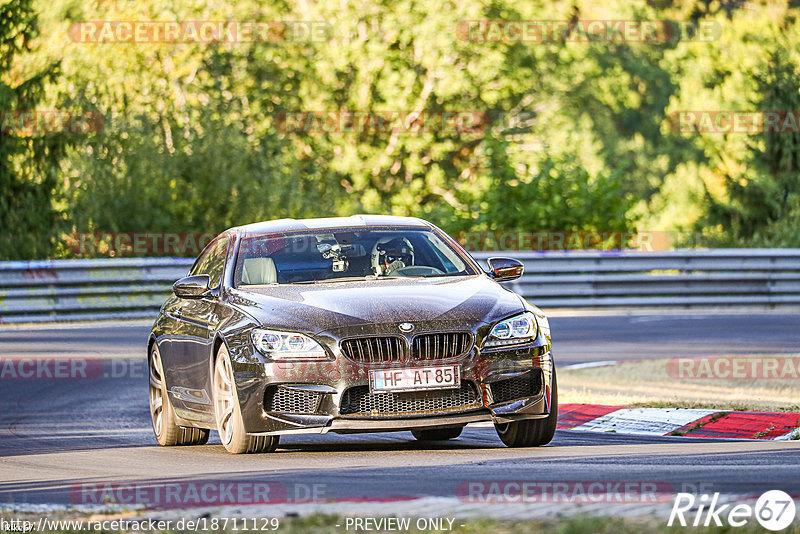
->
[229,215,433,235]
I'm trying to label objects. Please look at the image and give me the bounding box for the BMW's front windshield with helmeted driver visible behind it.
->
[234,228,478,287]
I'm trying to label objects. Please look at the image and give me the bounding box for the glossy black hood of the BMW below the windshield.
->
[225,275,524,334]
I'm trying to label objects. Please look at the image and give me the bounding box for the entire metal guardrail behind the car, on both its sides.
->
[0,249,800,323]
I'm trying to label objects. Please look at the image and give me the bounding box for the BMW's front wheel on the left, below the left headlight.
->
[214,343,279,454]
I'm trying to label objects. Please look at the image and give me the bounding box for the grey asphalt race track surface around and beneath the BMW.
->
[0,312,800,513]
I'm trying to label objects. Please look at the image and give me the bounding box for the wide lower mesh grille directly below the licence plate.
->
[339,382,481,417]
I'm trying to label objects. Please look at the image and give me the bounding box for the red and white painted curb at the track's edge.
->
[558,404,800,440]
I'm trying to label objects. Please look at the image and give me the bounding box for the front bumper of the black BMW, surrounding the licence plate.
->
[234,338,553,435]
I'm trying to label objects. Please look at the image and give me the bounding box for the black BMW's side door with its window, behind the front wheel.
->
[170,236,230,420]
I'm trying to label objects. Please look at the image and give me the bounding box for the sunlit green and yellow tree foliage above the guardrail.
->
[0,0,800,258]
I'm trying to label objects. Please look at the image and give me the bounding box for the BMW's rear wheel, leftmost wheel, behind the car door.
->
[148,343,211,447]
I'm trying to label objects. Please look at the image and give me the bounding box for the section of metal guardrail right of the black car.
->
[473,249,800,308]
